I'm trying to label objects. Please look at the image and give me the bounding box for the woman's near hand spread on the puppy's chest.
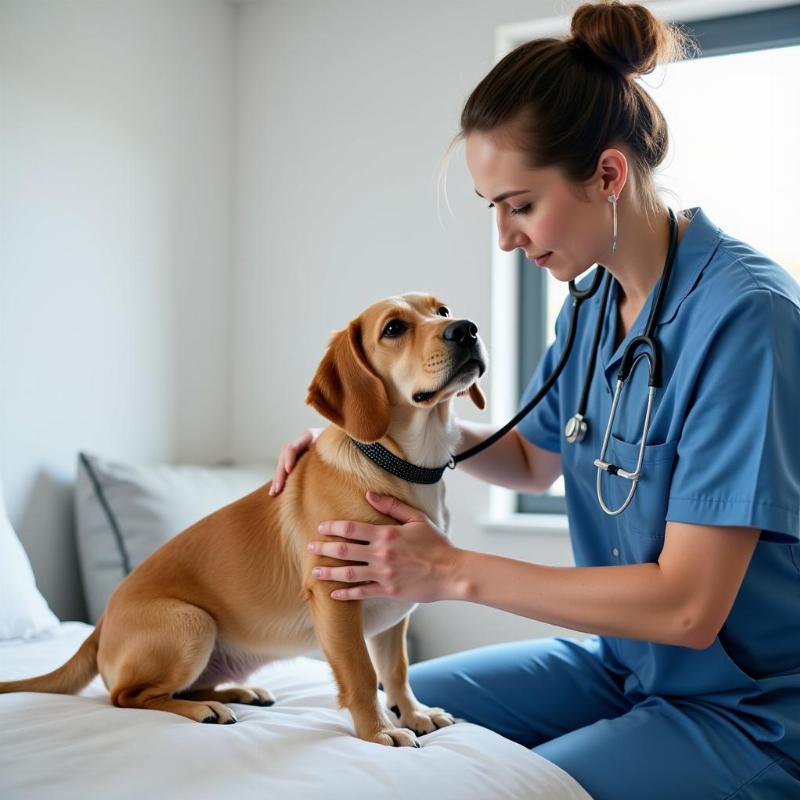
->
[308,492,460,603]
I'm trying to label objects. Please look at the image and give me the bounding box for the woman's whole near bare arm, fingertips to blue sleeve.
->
[308,500,760,649]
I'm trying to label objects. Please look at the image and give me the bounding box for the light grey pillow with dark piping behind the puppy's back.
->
[75,453,275,623]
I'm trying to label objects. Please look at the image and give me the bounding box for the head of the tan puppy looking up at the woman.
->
[306,294,487,442]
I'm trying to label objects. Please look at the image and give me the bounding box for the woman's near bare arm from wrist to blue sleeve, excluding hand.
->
[442,522,760,649]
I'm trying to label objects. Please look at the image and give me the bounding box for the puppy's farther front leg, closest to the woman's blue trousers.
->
[367,615,455,736]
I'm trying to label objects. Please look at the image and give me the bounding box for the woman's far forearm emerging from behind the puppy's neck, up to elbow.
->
[456,419,534,493]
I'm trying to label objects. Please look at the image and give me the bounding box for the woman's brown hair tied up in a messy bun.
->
[440,0,693,222]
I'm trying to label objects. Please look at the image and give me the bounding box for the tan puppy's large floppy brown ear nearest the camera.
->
[306,319,389,442]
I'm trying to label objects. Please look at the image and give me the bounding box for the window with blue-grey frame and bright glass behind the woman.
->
[517,5,800,513]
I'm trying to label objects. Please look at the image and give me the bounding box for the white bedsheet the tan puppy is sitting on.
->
[0,622,589,800]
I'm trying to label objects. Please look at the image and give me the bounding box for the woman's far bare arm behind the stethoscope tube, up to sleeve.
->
[456,419,561,494]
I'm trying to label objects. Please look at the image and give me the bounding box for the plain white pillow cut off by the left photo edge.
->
[0,476,59,639]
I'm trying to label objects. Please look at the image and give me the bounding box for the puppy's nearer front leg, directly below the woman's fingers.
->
[306,582,420,747]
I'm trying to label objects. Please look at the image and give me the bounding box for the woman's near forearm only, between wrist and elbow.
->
[443,550,708,647]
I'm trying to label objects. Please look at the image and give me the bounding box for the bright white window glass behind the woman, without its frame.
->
[547,46,800,495]
